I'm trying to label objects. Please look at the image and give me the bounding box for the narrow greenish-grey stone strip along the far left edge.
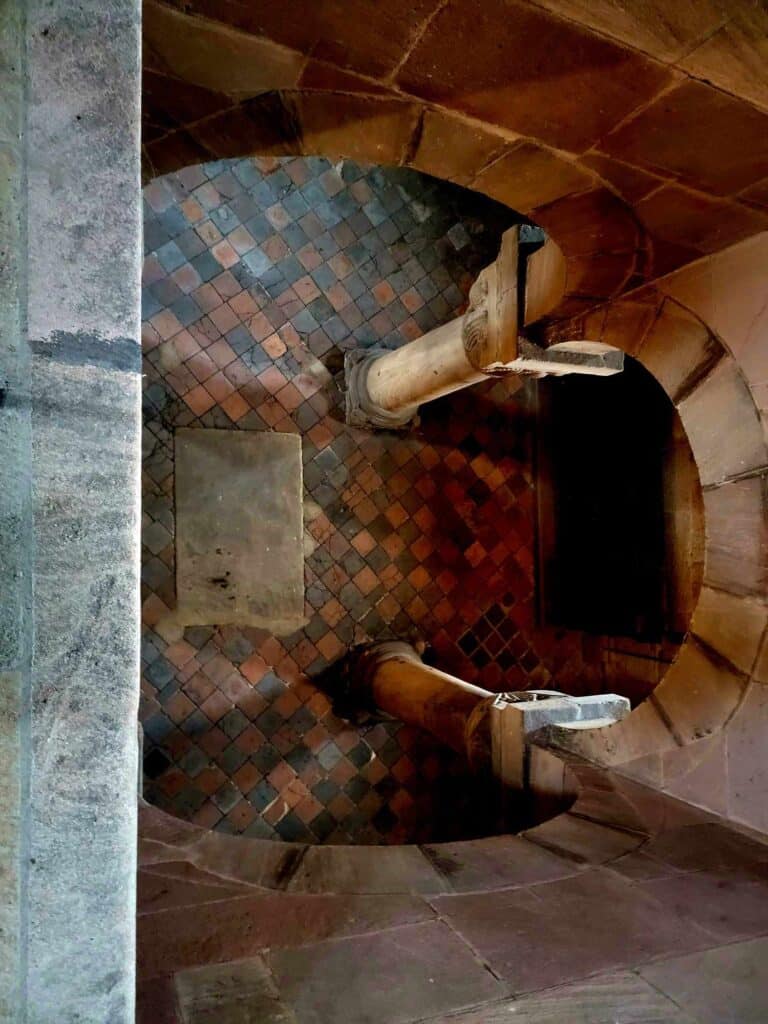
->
[0,2,25,1020]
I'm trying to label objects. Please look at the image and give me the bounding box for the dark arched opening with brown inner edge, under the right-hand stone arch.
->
[536,356,703,703]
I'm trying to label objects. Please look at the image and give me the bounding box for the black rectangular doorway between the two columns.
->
[538,357,680,642]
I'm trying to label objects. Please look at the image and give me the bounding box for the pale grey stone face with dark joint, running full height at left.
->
[0,0,141,1024]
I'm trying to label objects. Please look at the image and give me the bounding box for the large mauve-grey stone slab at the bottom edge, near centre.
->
[268,922,505,1024]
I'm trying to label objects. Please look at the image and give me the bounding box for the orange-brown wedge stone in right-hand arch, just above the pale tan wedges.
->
[638,299,725,402]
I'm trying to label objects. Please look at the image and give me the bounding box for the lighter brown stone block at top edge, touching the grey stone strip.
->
[143,0,304,97]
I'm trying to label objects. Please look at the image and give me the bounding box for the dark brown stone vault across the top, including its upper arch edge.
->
[144,0,768,315]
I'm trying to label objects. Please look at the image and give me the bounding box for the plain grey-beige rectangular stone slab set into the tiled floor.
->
[176,429,304,635]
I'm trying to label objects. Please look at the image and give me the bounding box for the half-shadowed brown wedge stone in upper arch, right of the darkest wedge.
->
[296,92,416,165]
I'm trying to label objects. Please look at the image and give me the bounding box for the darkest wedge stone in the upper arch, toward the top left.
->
[189,92,301,159]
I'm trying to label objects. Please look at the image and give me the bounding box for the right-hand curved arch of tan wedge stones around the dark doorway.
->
[540,270,768,826]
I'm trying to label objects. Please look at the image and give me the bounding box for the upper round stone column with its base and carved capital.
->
[345,227,624,430]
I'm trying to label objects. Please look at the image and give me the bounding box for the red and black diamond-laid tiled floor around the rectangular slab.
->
[140,159,618,843]
